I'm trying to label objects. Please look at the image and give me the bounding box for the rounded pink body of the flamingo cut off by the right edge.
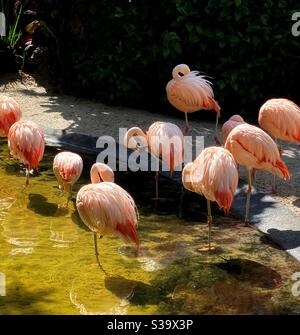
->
[258,99,300,143]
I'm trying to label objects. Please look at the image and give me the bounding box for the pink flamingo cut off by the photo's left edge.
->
[0,95,22,137]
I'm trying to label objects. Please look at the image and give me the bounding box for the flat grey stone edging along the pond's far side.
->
[44,128,300,261]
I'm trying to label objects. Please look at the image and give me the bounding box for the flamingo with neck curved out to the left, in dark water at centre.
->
[124,121,184,199]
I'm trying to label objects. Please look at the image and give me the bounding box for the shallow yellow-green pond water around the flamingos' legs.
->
[0,141,300,314]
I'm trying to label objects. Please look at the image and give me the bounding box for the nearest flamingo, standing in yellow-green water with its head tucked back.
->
[76,163,140,272]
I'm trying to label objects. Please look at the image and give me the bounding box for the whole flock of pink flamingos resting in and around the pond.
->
[0,64,300,266]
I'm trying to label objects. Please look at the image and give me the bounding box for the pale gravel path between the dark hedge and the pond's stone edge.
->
[0,74,300,216]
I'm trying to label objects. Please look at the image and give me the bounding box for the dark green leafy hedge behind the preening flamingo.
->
[24,0,300,120]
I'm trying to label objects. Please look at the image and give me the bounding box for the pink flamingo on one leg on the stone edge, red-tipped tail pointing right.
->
[225,123,290,225]
